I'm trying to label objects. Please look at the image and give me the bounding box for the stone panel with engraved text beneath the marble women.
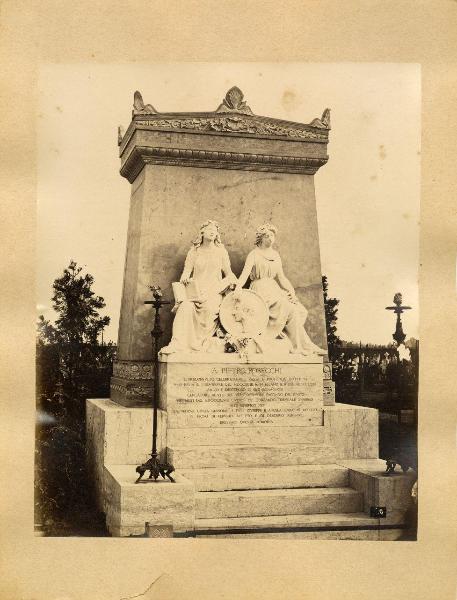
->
[162,363,323,428]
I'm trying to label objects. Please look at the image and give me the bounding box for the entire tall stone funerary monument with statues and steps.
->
[87,87,413,539]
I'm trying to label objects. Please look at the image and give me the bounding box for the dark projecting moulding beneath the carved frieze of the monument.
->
[120,146,328,183]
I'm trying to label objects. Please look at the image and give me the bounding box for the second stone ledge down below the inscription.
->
[167,444,336,470]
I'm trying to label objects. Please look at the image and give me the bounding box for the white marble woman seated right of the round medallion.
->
[235,223,326,355]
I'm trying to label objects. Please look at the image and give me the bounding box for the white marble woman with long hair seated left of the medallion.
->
[161,220,236,354]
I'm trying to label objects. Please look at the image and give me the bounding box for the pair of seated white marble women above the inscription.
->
[161,220,326,355]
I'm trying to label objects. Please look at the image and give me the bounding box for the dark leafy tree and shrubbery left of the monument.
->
[35,260,115,532]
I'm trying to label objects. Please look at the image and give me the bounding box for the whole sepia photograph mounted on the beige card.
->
[34,62,421,543]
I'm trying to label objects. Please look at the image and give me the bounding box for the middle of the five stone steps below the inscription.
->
[179,464,349,492]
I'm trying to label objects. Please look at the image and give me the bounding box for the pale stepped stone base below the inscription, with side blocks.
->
[87,399,415,540]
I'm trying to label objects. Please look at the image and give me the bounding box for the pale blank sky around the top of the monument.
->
[37,63,421,343]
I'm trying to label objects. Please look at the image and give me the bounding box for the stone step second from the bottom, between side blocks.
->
[196,487,363,519]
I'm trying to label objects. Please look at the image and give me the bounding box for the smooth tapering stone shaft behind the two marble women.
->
[118,164,326,360]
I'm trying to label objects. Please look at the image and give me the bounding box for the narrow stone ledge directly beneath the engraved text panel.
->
[167,425,324,446]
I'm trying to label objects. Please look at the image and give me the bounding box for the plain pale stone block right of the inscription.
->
[324,403,379,459]
